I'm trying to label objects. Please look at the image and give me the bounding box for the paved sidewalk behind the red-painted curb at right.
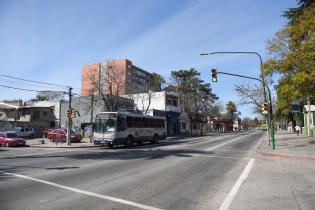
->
[257,131,315,161]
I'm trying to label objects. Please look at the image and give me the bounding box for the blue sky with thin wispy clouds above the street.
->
[0,0,297,117]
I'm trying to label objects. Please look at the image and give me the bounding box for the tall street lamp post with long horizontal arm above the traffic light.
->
[200,51,275,149]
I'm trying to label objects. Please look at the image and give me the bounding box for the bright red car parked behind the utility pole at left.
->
[47,129,82,143]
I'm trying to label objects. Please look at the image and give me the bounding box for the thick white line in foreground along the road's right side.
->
[219,158,255,210]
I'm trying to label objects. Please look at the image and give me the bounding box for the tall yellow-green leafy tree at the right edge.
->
[264,1,315,118]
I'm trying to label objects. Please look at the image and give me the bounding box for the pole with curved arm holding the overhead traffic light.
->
[217,71,276,150]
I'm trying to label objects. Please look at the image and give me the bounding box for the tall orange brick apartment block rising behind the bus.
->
[81,59,159,96]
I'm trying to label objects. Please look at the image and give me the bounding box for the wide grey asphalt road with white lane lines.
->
[0,132,263,210]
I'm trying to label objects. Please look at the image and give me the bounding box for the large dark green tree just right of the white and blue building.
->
[169,68,218,133]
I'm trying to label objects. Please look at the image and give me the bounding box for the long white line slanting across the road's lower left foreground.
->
[0,171,162,210]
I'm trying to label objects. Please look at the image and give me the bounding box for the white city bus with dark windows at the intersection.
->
[93,112,166,147]
